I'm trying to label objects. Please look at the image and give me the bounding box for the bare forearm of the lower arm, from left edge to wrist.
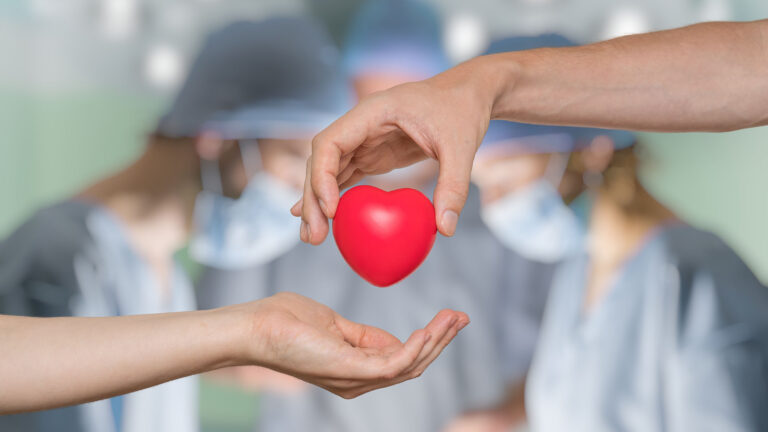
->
[0,310,246,414]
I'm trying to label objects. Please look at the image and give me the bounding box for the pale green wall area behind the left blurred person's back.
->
[0,89,163,235]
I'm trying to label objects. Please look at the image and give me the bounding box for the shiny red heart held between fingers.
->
[333,186,437,287]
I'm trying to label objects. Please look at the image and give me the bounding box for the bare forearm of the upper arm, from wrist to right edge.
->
[470,20,768,131]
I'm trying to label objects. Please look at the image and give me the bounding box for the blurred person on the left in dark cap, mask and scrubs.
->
[0,19,420,432]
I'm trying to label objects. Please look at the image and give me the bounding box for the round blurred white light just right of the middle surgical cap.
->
[443,13,488,63]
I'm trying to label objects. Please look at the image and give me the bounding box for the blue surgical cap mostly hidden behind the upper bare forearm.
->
[481,34,636,153]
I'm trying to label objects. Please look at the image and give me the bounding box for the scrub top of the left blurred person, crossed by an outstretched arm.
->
[0,200,198,432]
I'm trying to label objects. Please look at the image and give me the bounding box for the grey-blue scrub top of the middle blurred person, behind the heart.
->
[198,186,554,432]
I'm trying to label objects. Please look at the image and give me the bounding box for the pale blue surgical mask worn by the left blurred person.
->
[190,144,300,269]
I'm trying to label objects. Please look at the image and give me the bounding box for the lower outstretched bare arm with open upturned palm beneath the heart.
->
[0,294,469,414]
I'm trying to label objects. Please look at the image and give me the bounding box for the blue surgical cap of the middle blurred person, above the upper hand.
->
[343,0,450,79]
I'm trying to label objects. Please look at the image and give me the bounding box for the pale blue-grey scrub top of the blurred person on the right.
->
[526,225,768,432]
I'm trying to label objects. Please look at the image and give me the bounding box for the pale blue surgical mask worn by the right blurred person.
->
[482,154,586,262]
